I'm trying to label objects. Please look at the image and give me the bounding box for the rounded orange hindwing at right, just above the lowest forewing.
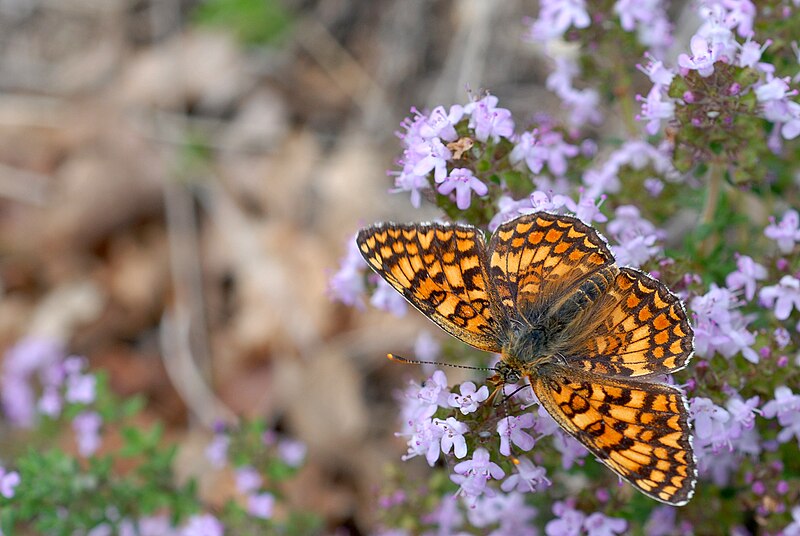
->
[565,268,694,377]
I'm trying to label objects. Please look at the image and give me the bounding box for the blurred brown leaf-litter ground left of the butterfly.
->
[0,0,628,532]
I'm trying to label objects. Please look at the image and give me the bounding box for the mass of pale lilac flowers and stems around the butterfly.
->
[339,0,800,535]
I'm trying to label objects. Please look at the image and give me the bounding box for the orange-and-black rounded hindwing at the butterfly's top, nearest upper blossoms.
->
[488,212,616,323]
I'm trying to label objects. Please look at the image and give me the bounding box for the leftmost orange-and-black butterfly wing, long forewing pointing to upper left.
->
[356,223,503,352]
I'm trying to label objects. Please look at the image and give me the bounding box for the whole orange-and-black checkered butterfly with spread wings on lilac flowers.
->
[356,212,697,506]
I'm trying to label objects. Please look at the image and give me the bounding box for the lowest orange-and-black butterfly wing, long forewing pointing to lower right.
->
[529,364,697,506]
